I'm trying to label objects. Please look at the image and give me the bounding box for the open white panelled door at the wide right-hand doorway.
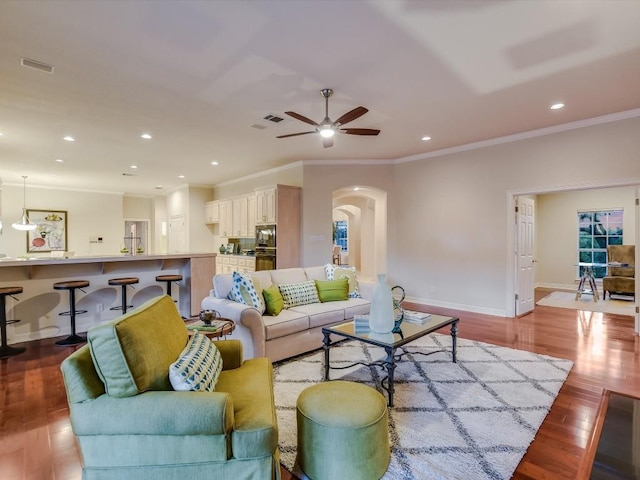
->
[516,197,535,316]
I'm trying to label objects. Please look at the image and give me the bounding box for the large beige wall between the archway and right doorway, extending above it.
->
[390,113,640,315]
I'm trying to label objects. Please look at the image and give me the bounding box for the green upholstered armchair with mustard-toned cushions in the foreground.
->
[61,296,280,480]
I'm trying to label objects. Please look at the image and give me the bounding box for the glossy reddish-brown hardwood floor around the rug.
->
[0,290,640,480]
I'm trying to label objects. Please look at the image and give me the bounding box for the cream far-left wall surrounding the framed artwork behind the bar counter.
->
[0,184,124,257]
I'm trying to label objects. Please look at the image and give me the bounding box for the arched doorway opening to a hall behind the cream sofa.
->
[332,185,387,278]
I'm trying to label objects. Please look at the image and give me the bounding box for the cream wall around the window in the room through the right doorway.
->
[535,187,635,287]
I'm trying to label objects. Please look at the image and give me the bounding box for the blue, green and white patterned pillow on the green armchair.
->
[169,332,222,392]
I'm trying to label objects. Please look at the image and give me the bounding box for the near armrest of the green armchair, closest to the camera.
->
[70,391,234,435]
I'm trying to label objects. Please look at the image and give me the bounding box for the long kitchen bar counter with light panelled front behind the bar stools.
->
[0,253,216,343]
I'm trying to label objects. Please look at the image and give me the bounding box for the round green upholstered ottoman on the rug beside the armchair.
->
[296,380,391,480]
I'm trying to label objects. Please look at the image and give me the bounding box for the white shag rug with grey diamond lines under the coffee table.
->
[274,334,573,480]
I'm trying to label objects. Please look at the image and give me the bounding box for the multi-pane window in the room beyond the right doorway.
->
[578,209,623,278]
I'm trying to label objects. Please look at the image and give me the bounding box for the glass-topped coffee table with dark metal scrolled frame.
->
[322,314,459,407]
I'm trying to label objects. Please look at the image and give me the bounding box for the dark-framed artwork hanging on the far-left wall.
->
[27,210,67,253]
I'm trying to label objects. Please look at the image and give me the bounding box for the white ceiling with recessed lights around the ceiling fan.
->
[0,0,640,195]
